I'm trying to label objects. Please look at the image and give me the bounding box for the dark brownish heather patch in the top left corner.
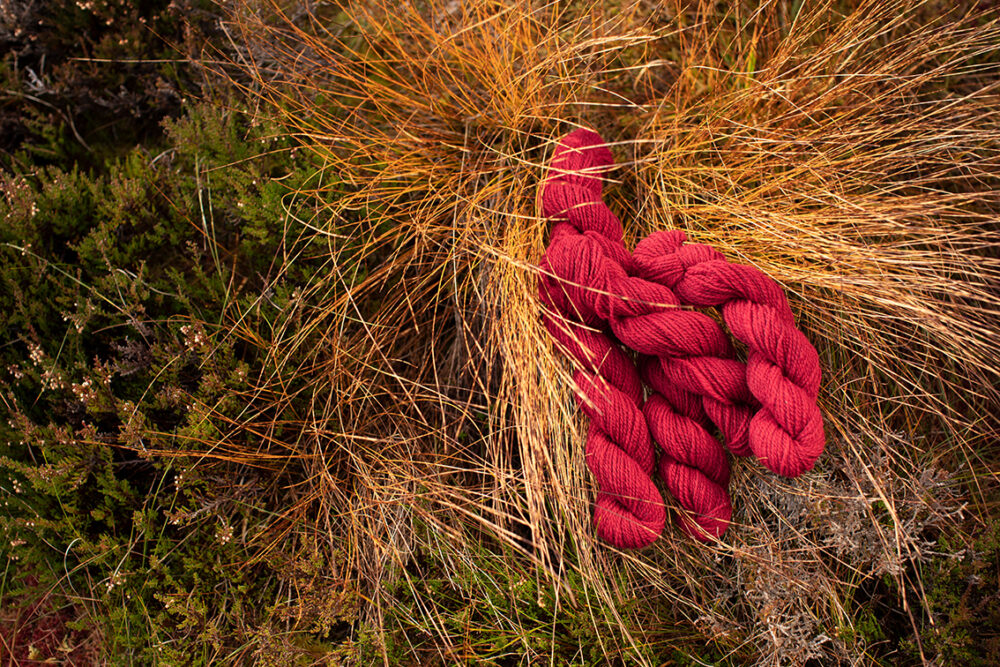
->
[0,0,218,169]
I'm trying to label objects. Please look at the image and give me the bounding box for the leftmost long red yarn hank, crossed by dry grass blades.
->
[539,137,666,548]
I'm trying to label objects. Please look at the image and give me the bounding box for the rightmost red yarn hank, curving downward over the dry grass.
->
[629,231,825,477]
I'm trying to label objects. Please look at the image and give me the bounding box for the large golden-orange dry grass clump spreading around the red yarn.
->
[205,0,1000,664]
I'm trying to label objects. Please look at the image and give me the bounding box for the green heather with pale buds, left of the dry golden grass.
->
[0,105,355,664]
